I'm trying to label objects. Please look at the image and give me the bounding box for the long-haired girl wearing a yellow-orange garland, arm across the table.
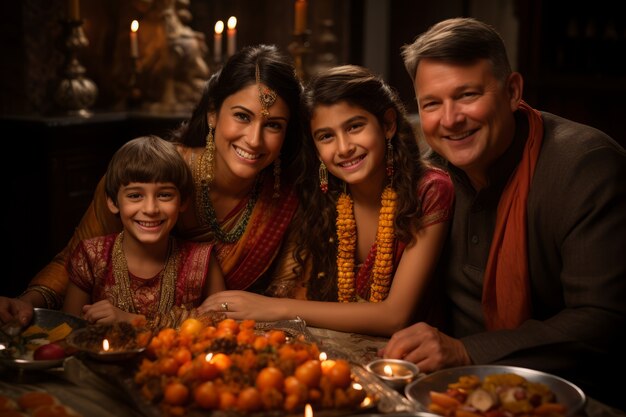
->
[199,65,453,336]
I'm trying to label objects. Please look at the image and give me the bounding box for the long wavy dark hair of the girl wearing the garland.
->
[295,65,425,300]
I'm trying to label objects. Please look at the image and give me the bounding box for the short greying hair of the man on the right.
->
[401,17,511,82]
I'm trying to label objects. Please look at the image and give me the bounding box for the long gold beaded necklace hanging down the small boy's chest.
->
[112,232,179,314]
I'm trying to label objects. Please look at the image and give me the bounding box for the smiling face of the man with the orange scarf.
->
[414,59,522,188]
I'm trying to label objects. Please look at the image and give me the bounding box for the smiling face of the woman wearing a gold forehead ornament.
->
[209,84,290,180]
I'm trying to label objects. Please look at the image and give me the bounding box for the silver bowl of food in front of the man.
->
[405,365,586,417]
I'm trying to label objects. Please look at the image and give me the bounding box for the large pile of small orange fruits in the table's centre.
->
[134,318,371,416]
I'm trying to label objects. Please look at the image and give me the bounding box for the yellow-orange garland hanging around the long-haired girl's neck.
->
[336,186,398,303]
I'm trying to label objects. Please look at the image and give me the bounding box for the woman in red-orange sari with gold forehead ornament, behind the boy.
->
[0,45,302,324]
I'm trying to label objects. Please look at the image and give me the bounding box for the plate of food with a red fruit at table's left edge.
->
[0,308,86,369]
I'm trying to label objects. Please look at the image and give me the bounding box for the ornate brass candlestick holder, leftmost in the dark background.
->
[55,19,98,117]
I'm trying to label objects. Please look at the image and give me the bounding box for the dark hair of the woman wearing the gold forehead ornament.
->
[166,45,302,174]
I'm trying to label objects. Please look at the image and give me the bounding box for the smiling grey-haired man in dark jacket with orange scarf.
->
[381,18,626,409]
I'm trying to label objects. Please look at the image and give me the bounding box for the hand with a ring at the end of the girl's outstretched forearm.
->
[198,291,286,321]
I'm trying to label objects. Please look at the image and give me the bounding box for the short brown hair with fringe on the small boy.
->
[105,135,193,205]
